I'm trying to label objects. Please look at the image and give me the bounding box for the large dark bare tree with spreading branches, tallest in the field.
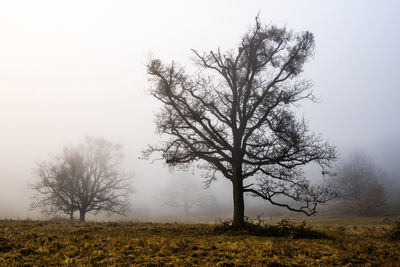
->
[143,18,336,228]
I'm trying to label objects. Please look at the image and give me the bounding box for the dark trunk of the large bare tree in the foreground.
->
[232,175,244,230]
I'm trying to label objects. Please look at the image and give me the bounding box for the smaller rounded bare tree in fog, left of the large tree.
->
[32,138,131,221]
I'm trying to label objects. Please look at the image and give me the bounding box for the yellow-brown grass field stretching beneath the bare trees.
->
[0,220,400,266]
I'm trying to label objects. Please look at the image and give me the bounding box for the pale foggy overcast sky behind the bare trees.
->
[0,0,400,218]
